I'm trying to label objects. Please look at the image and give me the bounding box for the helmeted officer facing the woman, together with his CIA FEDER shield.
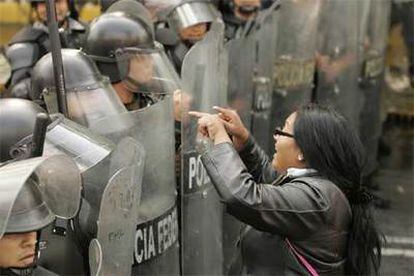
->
[85,0,179,275]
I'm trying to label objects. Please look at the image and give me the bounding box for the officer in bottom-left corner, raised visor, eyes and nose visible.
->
[0,155,81,275]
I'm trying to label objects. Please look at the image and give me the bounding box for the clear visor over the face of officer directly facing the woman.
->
[116,44,180,102]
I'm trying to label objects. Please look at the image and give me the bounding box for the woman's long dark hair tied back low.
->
[294,104,383,275]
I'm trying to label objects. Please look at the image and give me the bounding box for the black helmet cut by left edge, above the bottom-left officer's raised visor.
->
[0,98,46,163]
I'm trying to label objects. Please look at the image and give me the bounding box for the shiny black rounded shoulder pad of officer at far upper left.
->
[6,43,40,71]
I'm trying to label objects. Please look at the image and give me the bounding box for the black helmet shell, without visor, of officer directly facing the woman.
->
[85,0,155,83]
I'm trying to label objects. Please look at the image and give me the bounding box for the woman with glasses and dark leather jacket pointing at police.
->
[190,105,381,275]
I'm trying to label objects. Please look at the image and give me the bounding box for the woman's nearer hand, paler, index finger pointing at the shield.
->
[188,111,231,145]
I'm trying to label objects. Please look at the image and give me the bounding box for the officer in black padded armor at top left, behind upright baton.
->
[6,0,86,98]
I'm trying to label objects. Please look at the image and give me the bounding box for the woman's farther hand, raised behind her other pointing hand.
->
[213,106,249,151]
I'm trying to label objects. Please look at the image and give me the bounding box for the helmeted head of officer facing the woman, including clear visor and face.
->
[85,0,180,110]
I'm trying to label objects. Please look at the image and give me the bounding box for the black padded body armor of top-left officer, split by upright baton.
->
[6,18,85,99]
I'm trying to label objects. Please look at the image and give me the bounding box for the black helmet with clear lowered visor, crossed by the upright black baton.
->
[30,49,126,127]
